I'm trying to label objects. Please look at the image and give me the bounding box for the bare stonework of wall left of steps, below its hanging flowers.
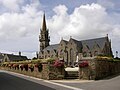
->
[0,63,64,80]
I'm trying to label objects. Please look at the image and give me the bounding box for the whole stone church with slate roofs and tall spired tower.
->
[38,14,113,65]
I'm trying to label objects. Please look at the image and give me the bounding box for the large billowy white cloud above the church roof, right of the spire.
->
[49,3,111,39]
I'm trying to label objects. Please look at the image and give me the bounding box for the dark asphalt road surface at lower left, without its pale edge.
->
[0,72,55,90]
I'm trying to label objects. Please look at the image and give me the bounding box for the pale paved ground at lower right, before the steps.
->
[53,75,120,90]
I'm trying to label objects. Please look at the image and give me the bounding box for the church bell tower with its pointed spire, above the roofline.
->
[39,13,50,51]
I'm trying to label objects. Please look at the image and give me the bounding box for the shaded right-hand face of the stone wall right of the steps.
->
[95,60,120,79]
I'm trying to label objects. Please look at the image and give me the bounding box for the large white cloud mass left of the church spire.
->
[0,0,43,58]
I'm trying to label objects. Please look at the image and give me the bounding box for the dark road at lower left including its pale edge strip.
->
[0,70,81,90]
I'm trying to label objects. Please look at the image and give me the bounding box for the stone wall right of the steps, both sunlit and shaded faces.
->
[79,59,120,80]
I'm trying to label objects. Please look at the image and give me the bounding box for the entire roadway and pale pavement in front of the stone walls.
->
[0,70,120,90]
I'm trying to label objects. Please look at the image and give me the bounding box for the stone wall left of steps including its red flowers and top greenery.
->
[1,58,64,79]
